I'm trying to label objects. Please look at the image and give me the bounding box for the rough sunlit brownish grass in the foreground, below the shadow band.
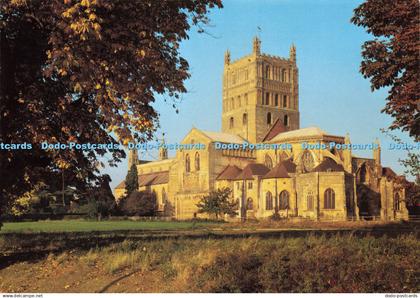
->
[0,234,420,293]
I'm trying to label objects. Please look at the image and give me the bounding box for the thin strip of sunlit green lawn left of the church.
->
[0,220,218,233]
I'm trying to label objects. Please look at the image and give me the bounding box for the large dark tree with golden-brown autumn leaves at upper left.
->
[0,0,222,212]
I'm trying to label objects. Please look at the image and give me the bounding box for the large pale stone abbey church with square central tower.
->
[115,38,408,220]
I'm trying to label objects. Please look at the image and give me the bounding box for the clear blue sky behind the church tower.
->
[106,0,412,188]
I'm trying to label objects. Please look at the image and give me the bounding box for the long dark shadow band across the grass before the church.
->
[0,222,420,270]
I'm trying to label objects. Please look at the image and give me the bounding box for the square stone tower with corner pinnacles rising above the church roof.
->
[222,37,299,143]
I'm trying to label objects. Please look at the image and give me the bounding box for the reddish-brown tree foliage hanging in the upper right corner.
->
[351,0,420,141]
